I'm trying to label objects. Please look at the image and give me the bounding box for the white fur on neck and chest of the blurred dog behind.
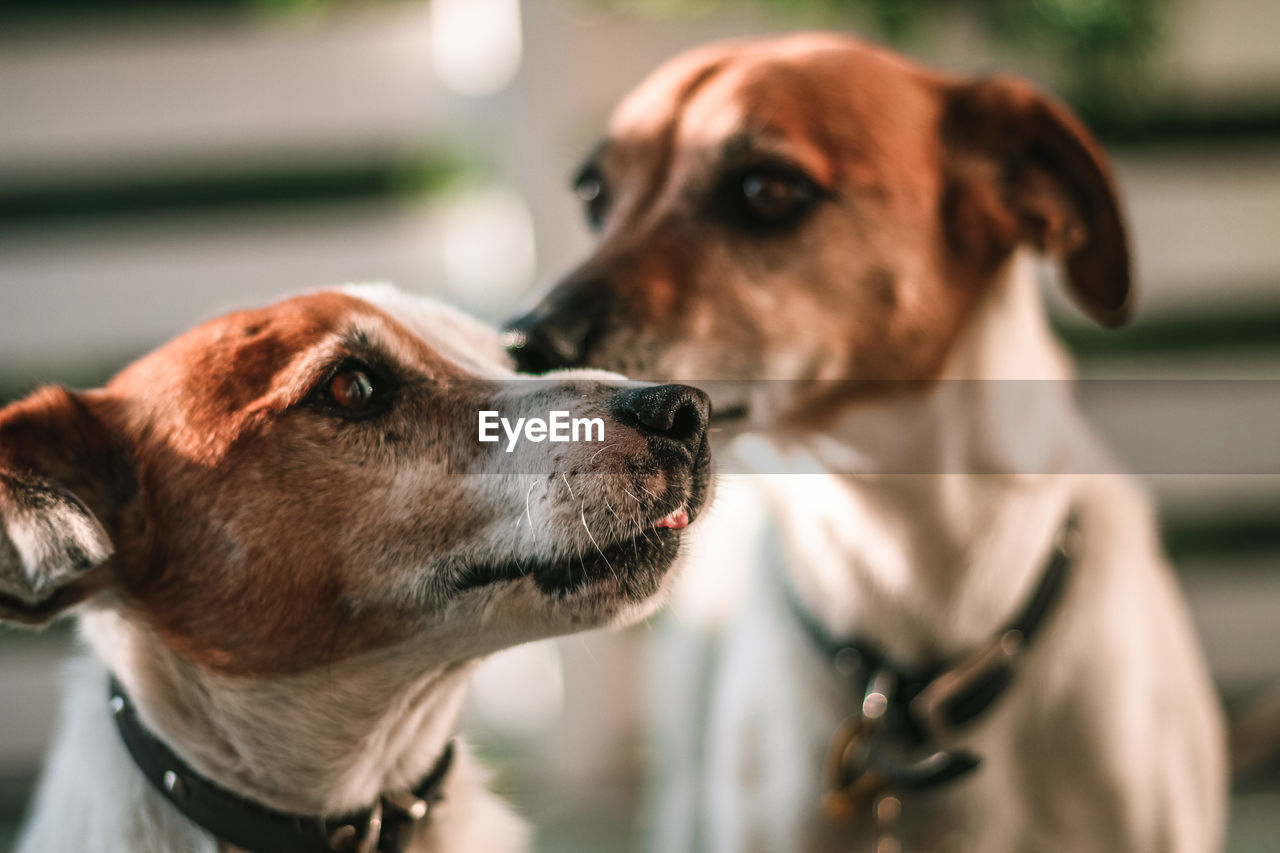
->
[657,257,1226,853]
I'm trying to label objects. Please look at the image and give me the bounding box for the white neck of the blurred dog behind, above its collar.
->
[745,256,1087,662]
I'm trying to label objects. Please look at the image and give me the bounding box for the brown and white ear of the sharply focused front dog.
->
[0,388,136,625]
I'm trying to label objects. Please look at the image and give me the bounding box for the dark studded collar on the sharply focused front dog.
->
[109,675,454,853]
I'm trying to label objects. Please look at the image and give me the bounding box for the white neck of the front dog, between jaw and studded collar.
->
[82,604,472,815]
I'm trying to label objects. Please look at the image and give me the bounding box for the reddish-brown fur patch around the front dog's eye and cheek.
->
[83,293,488,675]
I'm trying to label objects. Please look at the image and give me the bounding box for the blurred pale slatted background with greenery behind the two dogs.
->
[0,0,1280,853]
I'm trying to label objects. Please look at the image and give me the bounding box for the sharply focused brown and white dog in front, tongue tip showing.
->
[0,286,709,853]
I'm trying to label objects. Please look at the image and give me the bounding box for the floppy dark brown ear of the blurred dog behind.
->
[942,77,1133,327]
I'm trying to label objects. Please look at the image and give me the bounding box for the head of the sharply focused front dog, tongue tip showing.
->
[0,288,709,675]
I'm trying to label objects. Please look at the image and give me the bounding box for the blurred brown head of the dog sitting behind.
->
[509,33,1130,422]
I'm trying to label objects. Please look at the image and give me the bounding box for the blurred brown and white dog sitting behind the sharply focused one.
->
[511,33,1226,853]
